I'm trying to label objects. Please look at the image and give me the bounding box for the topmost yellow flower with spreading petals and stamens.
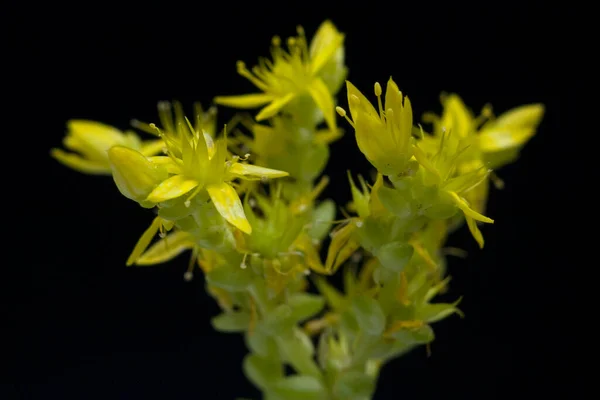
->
[215,21,345,130]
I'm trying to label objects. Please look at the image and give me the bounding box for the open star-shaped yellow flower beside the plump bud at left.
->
[146,120,288,234]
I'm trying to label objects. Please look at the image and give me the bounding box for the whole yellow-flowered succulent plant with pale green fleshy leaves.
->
[51,21,544,400]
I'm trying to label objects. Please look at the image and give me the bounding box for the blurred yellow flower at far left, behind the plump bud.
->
[50,120,164,175]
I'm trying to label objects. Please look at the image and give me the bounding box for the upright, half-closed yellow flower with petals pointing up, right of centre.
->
[336,78,412,175]
